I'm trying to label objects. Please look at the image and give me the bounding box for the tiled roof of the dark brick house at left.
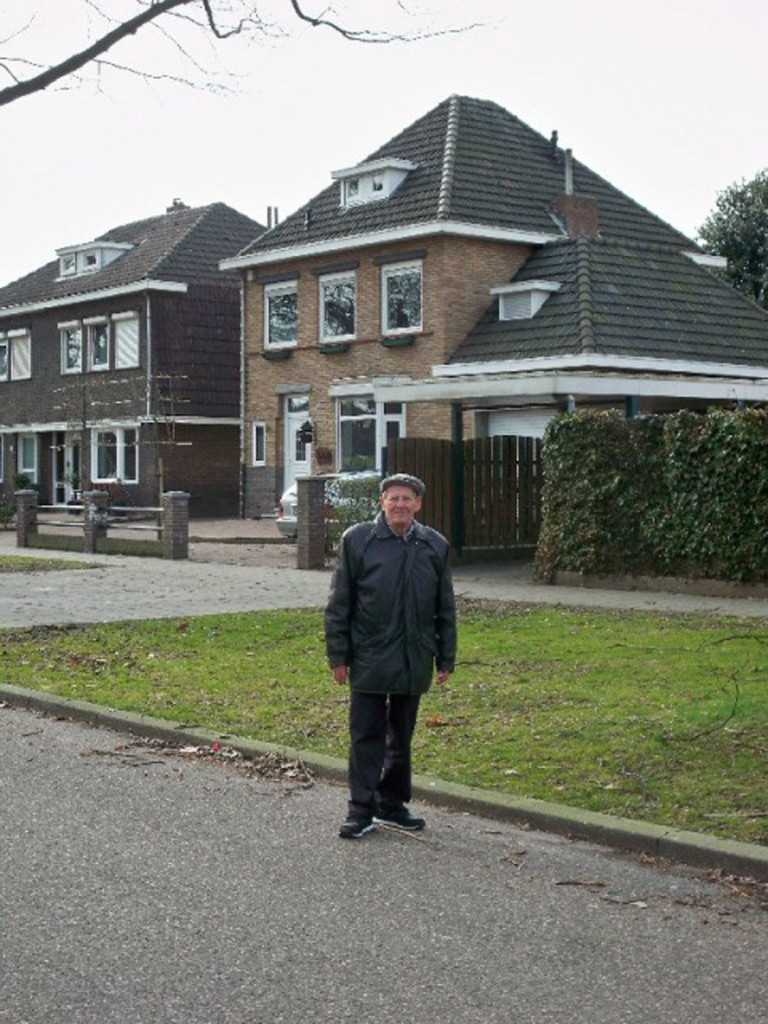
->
[0,203,264,309]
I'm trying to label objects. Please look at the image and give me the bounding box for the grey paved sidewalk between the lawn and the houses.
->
[0,519,768,627]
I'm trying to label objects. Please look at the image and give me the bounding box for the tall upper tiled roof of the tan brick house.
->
[241,96,696,256]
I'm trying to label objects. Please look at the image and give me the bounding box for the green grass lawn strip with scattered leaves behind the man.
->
[0,598,768,843]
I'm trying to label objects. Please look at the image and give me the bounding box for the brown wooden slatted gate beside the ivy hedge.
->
[387,436,542,552]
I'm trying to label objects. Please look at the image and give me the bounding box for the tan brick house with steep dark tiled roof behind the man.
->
[221,96,768,514]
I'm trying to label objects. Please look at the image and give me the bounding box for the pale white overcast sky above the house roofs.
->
[0,0,768,284]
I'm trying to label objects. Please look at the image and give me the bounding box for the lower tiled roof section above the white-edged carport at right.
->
[450,239,768,366]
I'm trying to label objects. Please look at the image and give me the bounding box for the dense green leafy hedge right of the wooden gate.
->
[537,409,768,582]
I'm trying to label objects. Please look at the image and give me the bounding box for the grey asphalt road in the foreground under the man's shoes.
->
[0,708,768,1024]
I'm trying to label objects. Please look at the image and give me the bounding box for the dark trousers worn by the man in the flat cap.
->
[349,690,420,817]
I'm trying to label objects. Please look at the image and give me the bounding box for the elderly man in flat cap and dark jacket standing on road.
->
[326,473,456,839]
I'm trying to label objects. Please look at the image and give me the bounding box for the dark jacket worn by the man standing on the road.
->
[326,513,456,693]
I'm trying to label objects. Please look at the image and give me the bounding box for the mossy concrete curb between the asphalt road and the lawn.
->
[0,684,768,882]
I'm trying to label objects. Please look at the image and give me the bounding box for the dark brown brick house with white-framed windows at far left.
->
[0,201,264,515]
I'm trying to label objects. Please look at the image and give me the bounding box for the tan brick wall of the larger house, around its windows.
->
[245,236,529,508]
